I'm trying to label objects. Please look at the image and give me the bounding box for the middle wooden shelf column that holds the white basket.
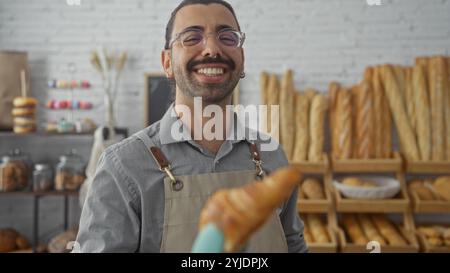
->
[326,153,419,252]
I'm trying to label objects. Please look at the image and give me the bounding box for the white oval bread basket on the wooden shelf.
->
[333,175,400,199]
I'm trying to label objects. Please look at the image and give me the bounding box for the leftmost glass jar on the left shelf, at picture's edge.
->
[0,149,31,191]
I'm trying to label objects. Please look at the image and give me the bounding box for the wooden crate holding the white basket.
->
[327,173,410,213]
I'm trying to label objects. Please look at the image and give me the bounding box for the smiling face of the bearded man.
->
[165,4,244,103]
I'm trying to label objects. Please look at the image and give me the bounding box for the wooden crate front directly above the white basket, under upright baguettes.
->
[331,153,403,173]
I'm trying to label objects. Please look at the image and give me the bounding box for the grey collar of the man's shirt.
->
[159,103,252,145]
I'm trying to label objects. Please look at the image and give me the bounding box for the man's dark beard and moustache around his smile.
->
[172,57,241,103]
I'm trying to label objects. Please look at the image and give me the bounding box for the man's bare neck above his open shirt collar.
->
[175,92,232,154]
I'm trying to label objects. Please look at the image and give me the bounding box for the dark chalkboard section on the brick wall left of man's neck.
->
[144,73,174,127]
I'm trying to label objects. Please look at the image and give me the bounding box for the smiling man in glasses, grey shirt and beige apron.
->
[77,0,307,252]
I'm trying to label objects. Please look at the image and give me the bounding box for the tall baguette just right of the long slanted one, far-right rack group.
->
[412,64,431,161]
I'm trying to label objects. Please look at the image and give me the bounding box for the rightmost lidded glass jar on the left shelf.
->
[55,150,86,191]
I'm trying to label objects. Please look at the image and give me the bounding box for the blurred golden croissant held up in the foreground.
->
[199,167,301,252]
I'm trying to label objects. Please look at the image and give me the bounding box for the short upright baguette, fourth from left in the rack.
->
[292,93,309,162]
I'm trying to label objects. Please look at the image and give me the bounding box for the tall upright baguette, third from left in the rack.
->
[280,70,295,160]
